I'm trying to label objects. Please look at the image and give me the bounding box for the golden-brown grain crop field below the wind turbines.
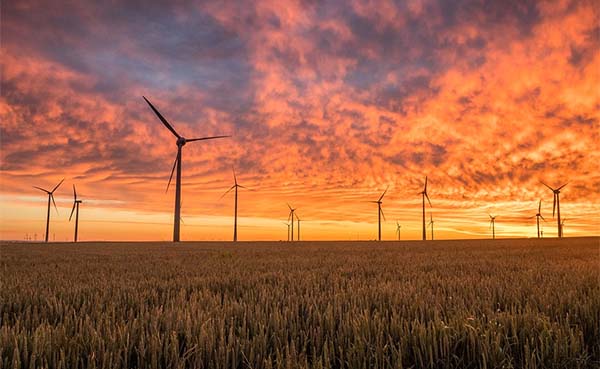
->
[0,238,600,369]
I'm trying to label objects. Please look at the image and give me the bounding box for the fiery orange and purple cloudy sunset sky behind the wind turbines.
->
[0,0,600,241]
